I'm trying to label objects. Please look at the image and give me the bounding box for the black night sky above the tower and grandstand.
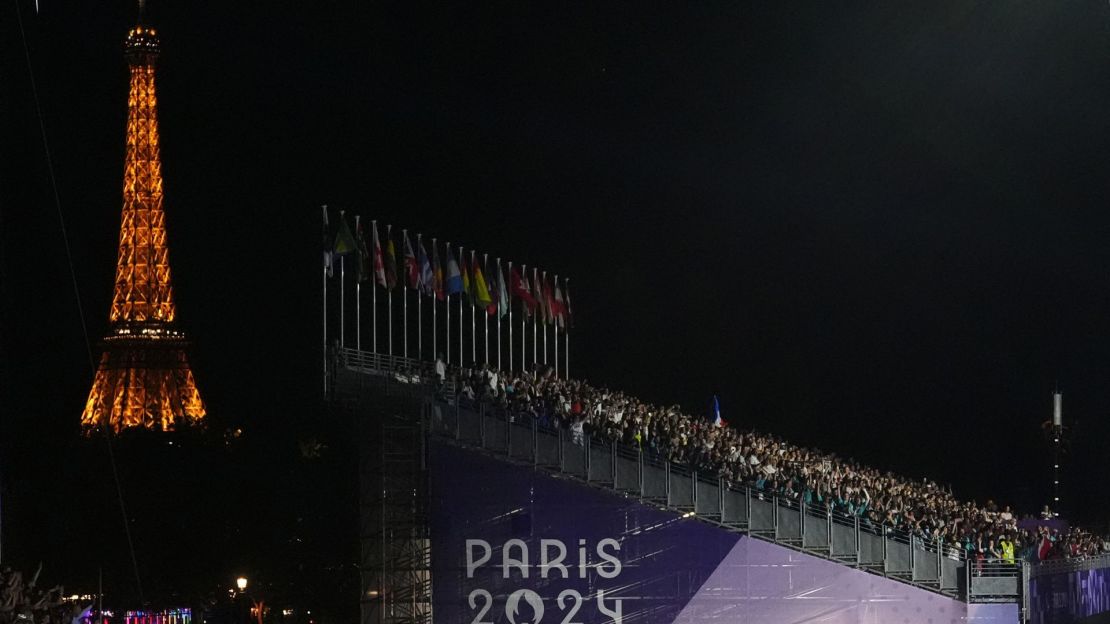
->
[0,0,1110,604]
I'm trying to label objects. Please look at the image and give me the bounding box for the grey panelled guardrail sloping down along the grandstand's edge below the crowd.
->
[336,349,1028,602]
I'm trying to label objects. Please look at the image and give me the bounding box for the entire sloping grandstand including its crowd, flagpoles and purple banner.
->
[324,219,1110,624]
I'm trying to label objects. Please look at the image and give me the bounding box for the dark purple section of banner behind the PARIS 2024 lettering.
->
[430,443,740,624]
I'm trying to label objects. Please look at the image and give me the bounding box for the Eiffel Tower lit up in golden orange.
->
[81,6,204,434]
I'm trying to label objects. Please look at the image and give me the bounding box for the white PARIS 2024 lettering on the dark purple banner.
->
[466,539,623,624]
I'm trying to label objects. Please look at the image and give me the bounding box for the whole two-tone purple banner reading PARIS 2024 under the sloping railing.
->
[428,442,1018,624]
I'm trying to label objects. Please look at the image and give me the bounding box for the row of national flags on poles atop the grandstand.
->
[324,208,574,328]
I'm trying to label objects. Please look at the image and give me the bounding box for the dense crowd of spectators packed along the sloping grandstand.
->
[415,360,1110,563]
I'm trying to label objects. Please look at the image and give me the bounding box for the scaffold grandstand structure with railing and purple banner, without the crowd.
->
[327,349,1110,624]
